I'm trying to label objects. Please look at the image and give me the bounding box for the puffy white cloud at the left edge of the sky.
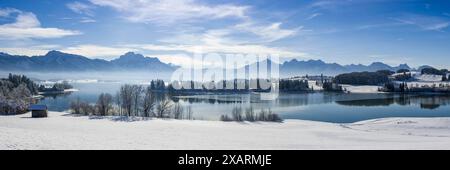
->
[0,9,81,40]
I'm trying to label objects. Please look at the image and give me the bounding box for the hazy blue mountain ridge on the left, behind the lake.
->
[0,51,177,72]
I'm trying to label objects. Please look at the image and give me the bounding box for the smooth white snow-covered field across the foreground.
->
[0,112,450,149]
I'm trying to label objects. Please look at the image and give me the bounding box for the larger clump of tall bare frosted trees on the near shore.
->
[70,85,194,119]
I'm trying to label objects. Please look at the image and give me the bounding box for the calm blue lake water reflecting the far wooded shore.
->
[36,82,450,123]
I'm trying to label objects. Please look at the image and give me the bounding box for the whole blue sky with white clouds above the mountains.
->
[0,0,450,68]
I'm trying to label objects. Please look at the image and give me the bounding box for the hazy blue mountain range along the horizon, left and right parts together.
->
[0,51,429,76]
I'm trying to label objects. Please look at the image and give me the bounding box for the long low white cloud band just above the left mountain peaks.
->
[56,35,309,66]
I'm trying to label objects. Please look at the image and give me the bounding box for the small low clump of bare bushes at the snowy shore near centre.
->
[220,107,283,122]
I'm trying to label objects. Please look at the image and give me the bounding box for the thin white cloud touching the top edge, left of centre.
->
[90,0,249,25]
